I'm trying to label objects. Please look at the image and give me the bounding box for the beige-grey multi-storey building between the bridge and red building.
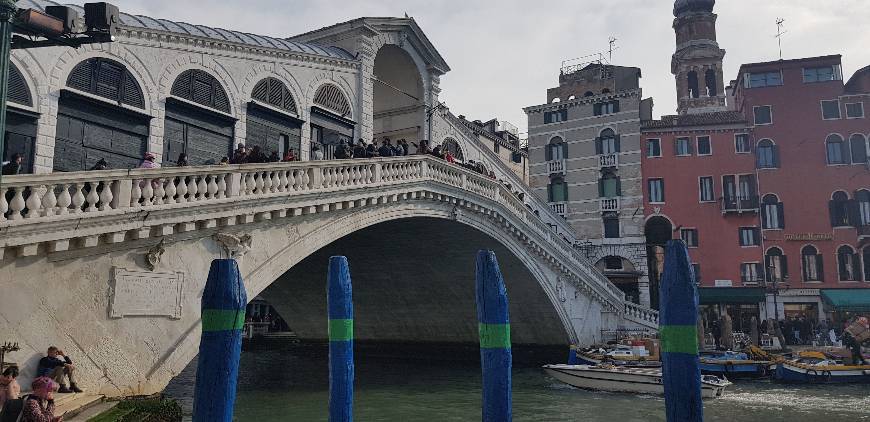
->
[525,62,652,305]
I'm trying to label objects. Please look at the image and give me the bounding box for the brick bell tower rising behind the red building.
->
[671,0,727,115]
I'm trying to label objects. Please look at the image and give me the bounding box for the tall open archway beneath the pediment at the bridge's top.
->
[372,44,426,143]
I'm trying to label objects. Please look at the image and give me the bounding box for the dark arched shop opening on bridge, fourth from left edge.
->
[245,77,302,157]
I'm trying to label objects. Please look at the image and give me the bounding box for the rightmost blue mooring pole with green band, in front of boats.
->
[659,240,704,422]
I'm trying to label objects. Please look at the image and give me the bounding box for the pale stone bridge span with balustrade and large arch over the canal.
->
[0,156,658,396]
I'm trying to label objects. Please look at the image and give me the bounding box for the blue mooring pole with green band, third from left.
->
[476,251,513,422]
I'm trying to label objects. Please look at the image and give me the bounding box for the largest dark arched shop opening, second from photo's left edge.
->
[54,58,151,171]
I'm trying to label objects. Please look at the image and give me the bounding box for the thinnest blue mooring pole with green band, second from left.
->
[326,256,353,422]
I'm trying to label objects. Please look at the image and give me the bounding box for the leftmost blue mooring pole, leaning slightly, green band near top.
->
[193,259,248,422]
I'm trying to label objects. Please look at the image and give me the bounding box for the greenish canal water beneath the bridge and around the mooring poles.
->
[166,345,870,422]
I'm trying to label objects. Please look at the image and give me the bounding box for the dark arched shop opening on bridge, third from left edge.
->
[163,69,236,166]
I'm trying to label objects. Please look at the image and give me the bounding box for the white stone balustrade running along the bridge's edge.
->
[0,156,639,313]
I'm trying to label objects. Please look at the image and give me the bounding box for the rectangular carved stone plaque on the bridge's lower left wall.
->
[109,267,184,319]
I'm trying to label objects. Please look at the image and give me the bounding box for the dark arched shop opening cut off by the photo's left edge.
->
[0,63,39,173]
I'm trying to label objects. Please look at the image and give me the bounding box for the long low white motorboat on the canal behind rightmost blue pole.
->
[544,364,731,399]
